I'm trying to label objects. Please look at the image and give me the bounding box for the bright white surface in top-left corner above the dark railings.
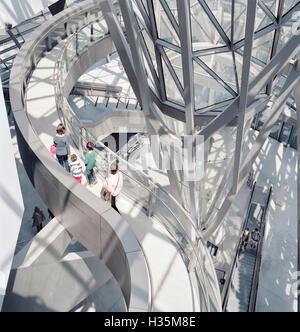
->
[0,0,74,29]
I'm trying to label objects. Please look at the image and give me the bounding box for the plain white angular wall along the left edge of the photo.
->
[0,80,24,311]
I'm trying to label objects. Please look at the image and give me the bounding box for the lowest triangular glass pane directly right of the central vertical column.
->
[194,61,233,109]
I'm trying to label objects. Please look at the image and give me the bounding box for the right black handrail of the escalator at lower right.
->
[248,186,273,312]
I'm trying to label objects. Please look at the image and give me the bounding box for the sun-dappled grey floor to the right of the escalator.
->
[253,138,298,312]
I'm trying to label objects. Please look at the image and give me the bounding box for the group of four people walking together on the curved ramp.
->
[50,123,123,213]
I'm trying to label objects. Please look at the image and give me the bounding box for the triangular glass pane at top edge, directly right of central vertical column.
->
[191,0,225,51]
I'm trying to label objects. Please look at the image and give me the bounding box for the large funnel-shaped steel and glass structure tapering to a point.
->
[104,0,300,236]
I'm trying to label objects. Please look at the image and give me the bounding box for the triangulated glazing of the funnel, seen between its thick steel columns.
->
[133,0,300,113]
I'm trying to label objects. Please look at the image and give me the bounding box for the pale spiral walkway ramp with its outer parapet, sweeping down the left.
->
[3,1,221,312]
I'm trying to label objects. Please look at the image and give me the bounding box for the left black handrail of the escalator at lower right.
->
[222,181,256,311]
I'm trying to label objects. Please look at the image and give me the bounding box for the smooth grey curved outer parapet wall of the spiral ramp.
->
[10,1,150,311]
